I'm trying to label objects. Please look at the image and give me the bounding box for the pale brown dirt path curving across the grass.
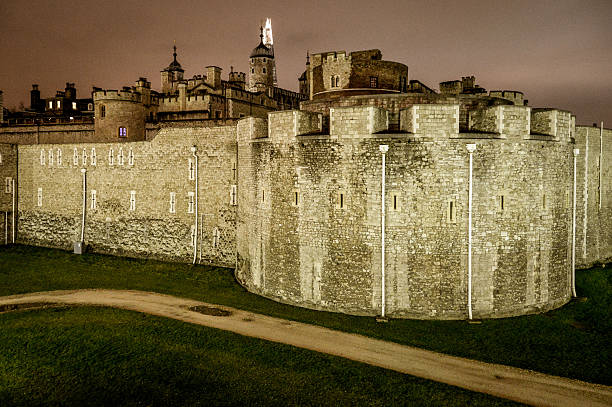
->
[0,290,612,407]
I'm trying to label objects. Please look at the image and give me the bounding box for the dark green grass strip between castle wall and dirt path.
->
[0,246,612,385]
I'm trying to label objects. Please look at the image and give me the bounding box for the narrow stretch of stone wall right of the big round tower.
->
[576,126,612,267]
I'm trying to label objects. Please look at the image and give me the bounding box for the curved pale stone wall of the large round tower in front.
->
[236,106,572,318]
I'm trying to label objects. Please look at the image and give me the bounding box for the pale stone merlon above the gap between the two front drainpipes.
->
[400,104,459,136]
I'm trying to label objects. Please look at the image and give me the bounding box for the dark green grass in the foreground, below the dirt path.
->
[0,307,516,406]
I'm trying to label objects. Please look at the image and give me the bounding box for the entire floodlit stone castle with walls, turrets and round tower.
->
[0,20,612,319]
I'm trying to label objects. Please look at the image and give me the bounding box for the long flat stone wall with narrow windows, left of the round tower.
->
[18,126,237,266]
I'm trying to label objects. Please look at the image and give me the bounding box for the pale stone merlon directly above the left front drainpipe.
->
[329,106,389,138]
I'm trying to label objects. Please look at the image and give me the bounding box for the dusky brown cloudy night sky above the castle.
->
[0,0,612,127]
